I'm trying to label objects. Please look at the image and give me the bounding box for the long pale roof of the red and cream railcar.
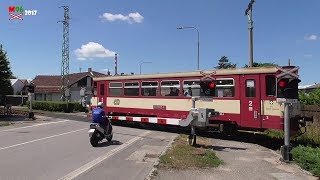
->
[93,67,278,81]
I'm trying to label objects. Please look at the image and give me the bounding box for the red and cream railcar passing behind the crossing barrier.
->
[91,67,299,129]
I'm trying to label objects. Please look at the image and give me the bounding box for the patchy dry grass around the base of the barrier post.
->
[159,135,223,169]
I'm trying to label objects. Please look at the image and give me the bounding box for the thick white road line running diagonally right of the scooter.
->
[59,131,151,180]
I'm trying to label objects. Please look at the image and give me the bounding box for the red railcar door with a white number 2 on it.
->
[240,74,262,128]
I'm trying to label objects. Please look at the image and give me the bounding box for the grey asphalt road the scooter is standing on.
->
[0,115,176,180]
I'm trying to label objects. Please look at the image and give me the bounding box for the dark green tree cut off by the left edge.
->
[0,44,13,105]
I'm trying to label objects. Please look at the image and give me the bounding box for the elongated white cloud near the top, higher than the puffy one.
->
[100,12,144,23]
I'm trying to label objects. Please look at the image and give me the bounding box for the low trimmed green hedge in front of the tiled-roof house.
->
[27,101,85,112]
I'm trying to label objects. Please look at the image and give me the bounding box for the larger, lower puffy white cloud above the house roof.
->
[74,42,115,60]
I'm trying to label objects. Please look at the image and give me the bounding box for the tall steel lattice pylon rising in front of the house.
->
[58,6,70,101]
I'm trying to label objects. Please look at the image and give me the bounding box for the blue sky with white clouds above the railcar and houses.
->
[0,0,320,85]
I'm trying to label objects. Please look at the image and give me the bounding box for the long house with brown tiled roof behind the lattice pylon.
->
[32,68,107,102]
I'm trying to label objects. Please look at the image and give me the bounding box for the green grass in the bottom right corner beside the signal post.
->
[292,146,320,177]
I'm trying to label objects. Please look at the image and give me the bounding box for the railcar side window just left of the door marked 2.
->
[214,79,234,98]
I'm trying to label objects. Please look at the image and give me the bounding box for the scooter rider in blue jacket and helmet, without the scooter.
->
[92,102,112,132]
